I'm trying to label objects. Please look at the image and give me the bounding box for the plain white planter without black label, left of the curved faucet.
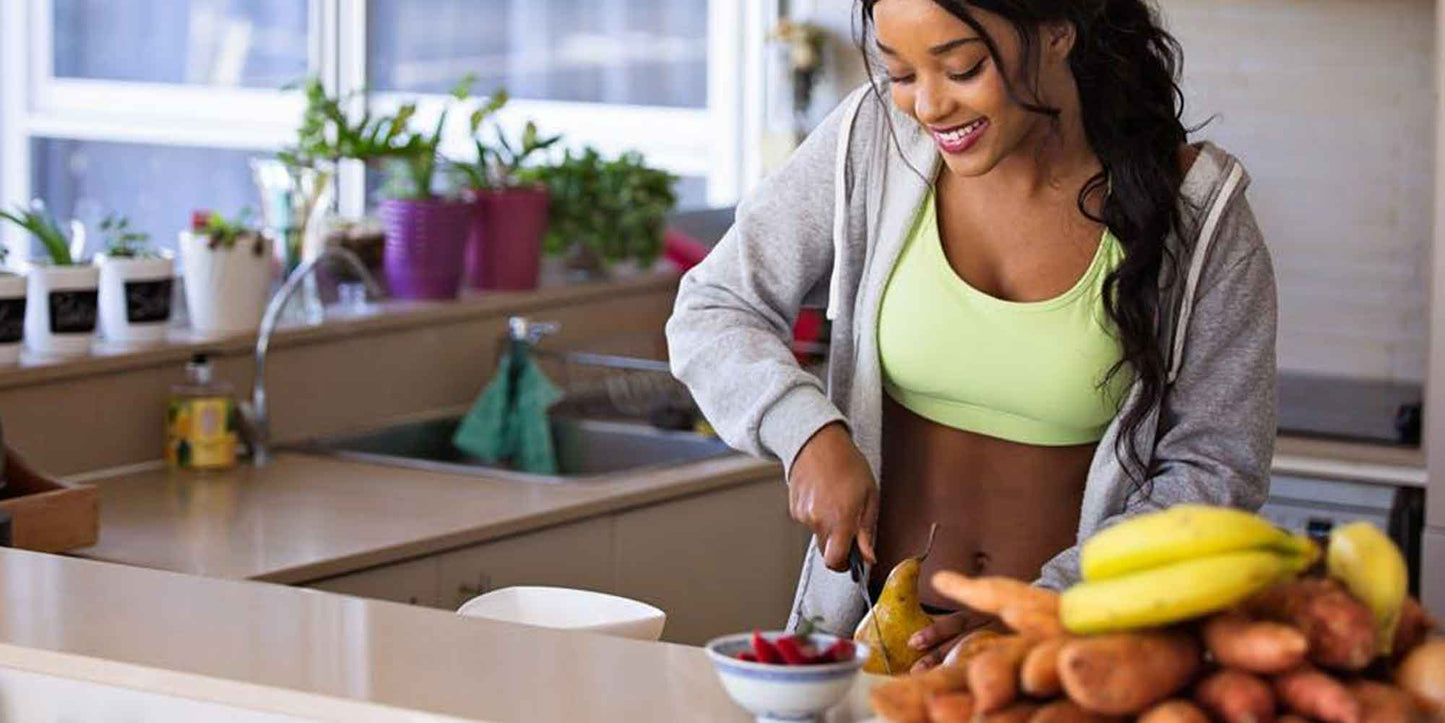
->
[181,231,273,337]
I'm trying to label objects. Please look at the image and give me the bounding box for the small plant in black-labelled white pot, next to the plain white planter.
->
[95,214,175,347]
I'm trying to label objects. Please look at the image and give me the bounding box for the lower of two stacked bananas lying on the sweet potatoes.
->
[1059,549,1314,635]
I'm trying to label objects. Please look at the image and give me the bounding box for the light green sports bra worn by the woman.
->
[877,191,1133,447]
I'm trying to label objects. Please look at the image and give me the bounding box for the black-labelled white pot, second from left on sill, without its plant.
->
[25,265,100,359]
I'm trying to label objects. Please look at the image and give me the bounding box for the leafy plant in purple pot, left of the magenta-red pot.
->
[380,77,471,299]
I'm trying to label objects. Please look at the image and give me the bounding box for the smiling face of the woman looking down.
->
[873,0,1051,176]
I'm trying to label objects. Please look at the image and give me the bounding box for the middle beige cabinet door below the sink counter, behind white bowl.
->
[427,518,613,610]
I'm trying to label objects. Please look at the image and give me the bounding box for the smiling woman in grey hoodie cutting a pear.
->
[668,0,1276,667]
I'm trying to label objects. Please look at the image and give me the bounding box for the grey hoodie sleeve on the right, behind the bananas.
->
[1038,195,1277,590]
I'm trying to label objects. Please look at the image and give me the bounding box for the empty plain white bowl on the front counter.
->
[457,587,668,641]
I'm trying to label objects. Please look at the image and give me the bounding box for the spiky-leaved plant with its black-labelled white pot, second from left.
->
[0,202,100,359]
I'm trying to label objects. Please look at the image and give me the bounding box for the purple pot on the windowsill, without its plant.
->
[380,200,473,299]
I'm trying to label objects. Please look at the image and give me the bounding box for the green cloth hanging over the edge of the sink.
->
[452,341,562,474]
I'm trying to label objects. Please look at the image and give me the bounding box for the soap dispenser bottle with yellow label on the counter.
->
[166,354,240,470]
